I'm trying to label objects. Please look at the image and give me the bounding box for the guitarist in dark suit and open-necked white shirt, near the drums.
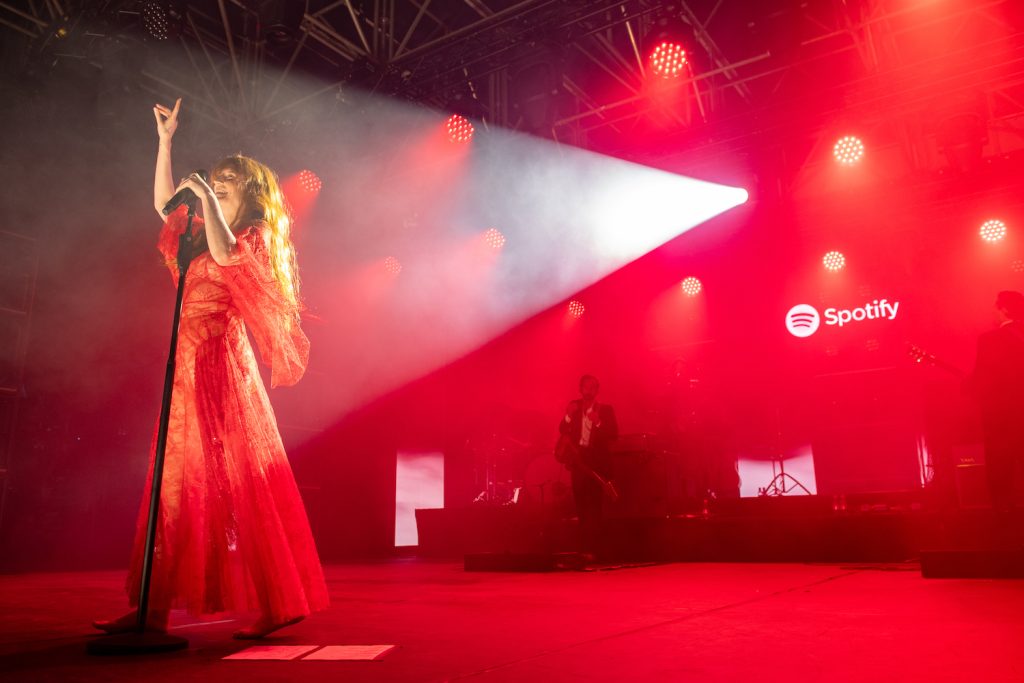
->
[556,375,618,556]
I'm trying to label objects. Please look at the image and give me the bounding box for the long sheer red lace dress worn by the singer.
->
[128,207,328,622]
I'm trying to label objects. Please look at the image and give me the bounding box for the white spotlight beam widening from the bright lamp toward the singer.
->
[305,109,746,419]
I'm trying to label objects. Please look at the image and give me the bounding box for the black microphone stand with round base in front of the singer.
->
[86,197,199,654]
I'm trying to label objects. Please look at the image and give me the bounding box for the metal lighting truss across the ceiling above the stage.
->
[0,0,1024,169]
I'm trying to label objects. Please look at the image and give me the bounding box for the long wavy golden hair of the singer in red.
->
[210,154,300,305]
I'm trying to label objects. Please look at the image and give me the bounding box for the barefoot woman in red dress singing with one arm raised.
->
[95,99,328,638]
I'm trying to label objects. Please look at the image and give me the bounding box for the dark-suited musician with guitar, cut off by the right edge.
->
[968,291,1024,514]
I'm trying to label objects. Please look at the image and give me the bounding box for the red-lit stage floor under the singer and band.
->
[0,560,1024,683]
